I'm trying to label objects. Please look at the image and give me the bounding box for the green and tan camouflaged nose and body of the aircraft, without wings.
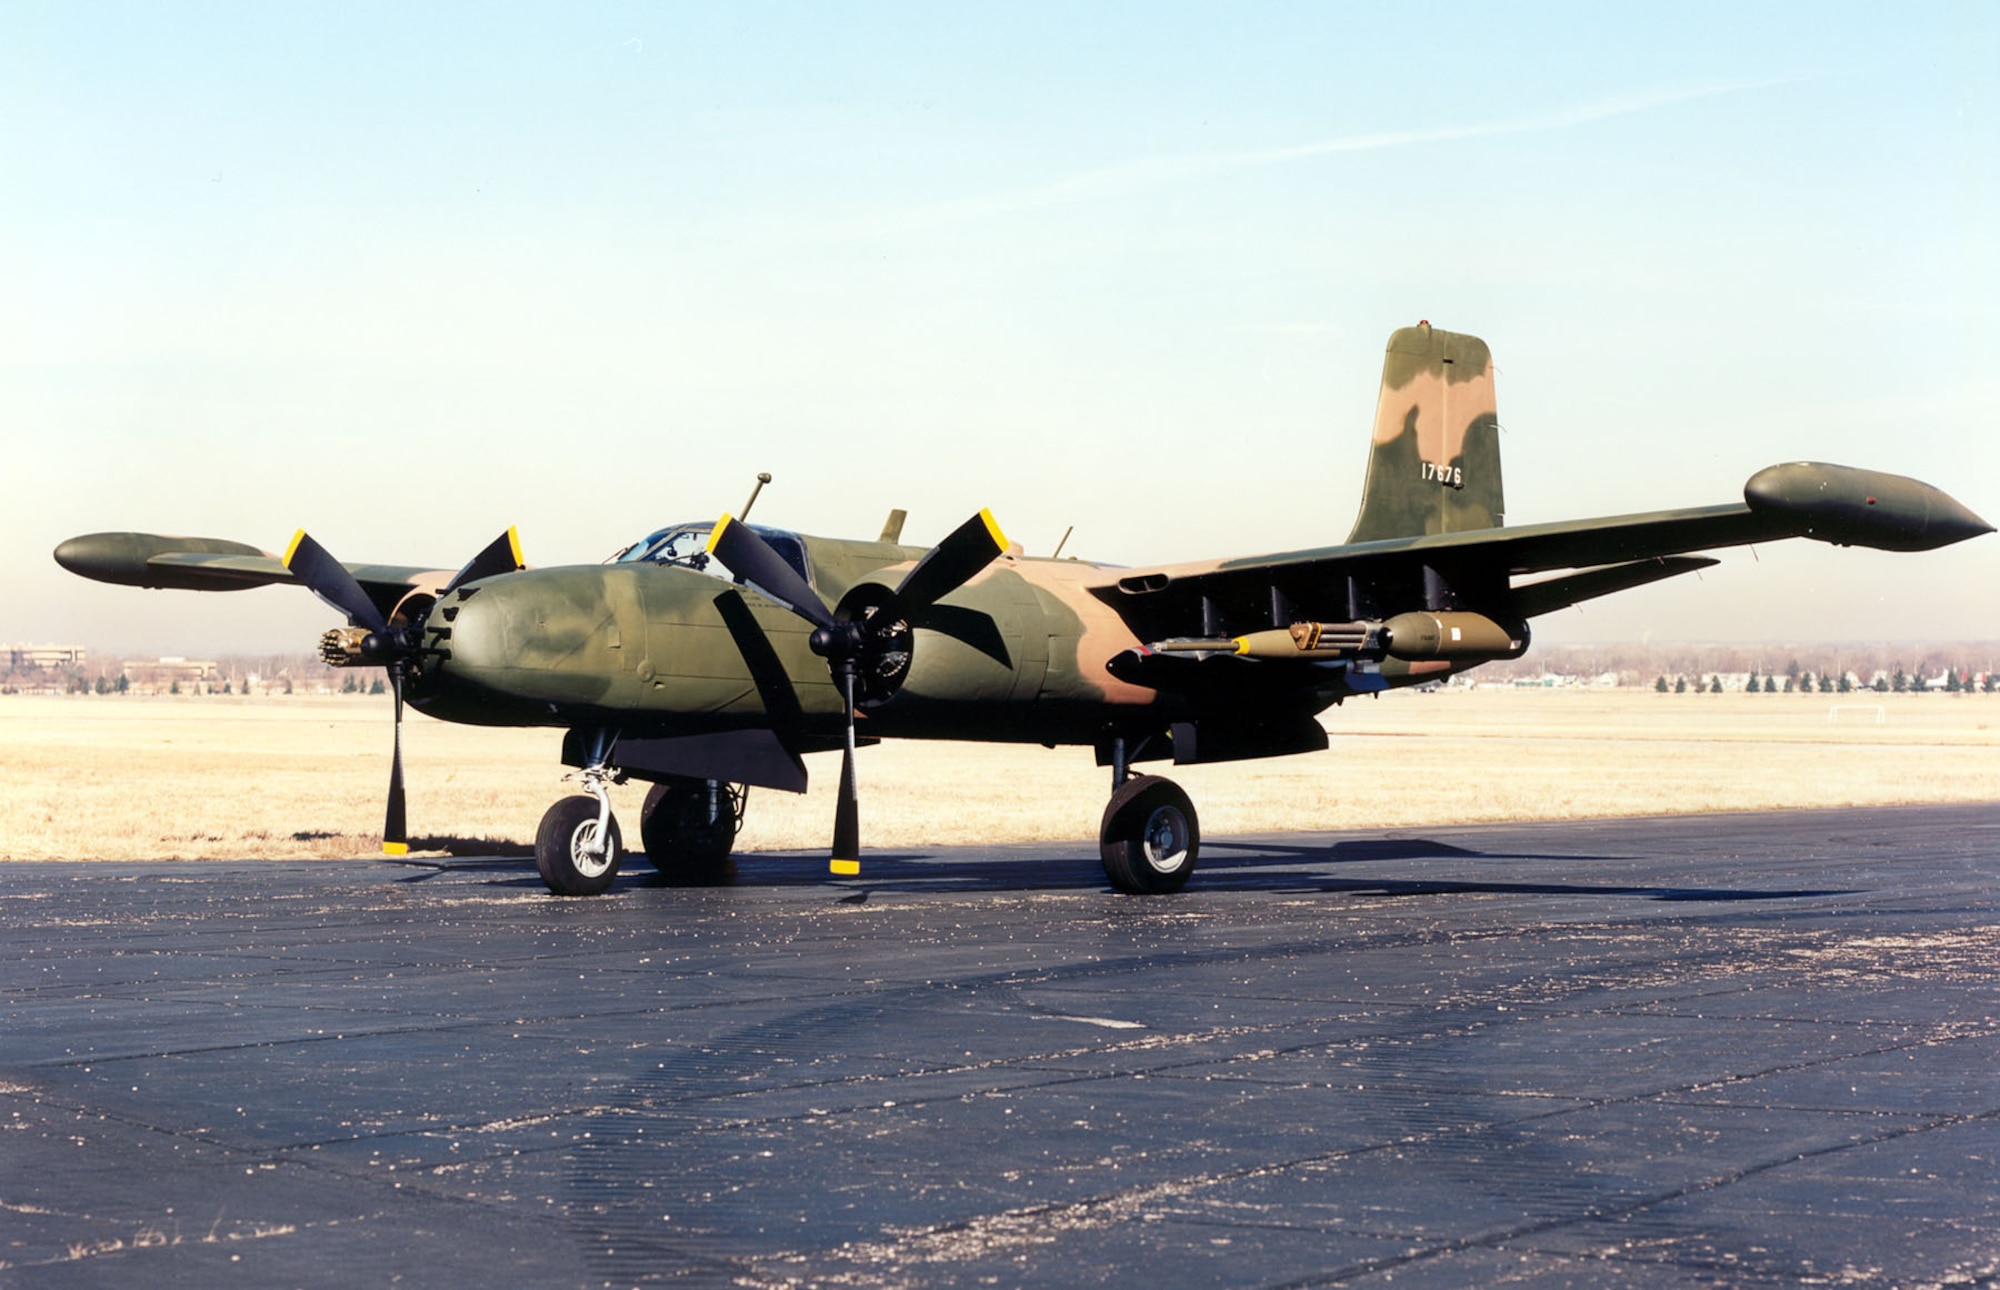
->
[410,538,1174,744]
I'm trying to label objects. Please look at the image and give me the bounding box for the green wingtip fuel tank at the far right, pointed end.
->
[1744,462,1994,550]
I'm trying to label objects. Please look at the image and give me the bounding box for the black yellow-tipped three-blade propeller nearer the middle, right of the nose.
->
[708,510,1008,876]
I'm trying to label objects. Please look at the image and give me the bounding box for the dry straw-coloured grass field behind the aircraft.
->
[0,690,2000,860]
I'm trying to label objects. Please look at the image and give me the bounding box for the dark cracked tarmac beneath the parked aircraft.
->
[0,806,2000,1288]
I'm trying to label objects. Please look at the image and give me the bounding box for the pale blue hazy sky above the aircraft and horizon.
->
[0,2,2000,652]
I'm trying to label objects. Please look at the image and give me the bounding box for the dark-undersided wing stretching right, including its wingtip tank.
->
[1092,462,1992,640]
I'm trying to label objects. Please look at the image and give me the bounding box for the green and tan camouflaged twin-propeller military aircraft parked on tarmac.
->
[56,322,1992,896]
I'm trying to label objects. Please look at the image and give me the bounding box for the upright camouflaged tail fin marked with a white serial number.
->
[1348,322,1506,542]
